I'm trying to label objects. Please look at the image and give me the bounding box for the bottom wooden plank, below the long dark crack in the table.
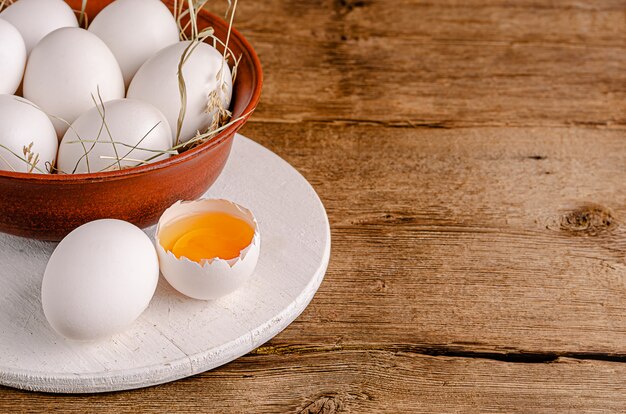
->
[0,349,626,414]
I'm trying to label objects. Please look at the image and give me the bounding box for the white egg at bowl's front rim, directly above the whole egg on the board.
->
[57,99,173,174]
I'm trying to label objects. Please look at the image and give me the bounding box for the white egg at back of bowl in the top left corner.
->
[0,0,78,53]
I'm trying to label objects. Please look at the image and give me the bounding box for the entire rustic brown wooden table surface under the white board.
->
[0,0,626,413]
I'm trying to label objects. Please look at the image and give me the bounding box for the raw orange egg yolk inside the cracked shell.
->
[164,212,254,262]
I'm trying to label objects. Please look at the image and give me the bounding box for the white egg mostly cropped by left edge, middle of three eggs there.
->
[0,19,26,94]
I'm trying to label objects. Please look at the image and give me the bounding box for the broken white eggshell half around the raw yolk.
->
[156,199,261,300]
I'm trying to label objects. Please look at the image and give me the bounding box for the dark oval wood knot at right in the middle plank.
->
[561,205,617,236]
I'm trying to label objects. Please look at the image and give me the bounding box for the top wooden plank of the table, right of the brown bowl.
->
[230,0,626,127]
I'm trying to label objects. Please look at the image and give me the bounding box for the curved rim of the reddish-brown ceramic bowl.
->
[0,9,263,184]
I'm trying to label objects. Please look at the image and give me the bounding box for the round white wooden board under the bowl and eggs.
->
[0,136,330,393]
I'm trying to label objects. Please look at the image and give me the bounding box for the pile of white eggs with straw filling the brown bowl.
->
[0,0,232,174]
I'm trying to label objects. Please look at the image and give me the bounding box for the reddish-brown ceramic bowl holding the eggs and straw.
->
[0,0,263,240]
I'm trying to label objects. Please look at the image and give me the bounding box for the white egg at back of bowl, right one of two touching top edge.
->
[89,0,178,86]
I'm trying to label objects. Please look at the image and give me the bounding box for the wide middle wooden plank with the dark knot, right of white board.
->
[238,123,626,357]
